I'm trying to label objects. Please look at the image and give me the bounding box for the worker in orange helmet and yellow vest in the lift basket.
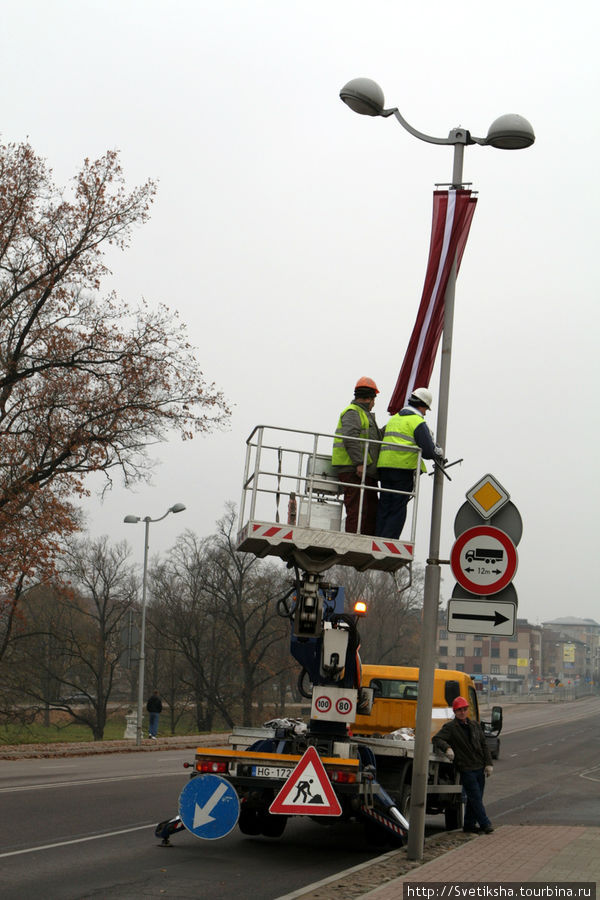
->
[331,376,382,535]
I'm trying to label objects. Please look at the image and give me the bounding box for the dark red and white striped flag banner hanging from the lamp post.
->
[388,190,477,415]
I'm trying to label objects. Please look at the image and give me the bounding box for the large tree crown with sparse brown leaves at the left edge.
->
[0,144,228,628]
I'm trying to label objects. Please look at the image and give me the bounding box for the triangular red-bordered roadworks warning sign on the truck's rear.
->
[269,747,342,816]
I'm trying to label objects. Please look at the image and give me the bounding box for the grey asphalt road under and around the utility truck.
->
[0,699,600,900]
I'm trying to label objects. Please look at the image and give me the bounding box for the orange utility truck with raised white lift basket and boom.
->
[156,426,502,844]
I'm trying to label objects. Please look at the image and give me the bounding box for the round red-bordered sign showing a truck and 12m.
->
[450,525,517,596]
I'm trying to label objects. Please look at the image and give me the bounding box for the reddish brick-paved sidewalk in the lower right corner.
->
[362,825,600,900]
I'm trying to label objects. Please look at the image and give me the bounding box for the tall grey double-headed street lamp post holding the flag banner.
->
[340,78,535,859]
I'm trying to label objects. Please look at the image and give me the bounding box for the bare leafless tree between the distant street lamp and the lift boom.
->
[149,505,290,730]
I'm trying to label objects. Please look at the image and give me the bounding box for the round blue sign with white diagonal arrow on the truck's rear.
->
[179,775,240,841]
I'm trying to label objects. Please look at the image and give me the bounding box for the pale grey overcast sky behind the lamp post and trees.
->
[0,0,600,622]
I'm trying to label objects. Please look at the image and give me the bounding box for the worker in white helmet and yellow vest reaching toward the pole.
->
[375,388,444,540]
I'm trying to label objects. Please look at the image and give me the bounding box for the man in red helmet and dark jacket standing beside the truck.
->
[433,697,494,834]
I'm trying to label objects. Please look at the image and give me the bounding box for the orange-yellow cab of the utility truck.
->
[352,665,480,736]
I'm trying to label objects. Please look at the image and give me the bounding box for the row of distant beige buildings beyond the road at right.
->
[437,612,600,694]
